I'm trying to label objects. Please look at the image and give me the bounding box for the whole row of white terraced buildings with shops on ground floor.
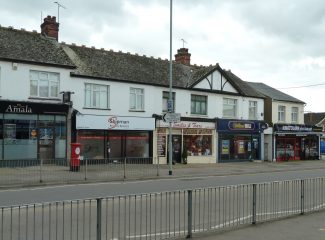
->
[0,16,325,164]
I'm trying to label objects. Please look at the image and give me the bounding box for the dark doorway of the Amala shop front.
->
[38,127,54,163]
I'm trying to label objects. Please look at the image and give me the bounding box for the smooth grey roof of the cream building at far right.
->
[248,82,305,104]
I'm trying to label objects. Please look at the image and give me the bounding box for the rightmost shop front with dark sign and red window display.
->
[274,124,322,161]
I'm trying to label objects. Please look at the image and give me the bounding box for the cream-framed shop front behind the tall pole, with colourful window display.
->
[154,120,216,163]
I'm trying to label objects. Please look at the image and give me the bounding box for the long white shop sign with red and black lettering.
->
[76,114,155,130]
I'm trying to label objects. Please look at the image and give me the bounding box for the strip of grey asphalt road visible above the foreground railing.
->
[0,168,325,206]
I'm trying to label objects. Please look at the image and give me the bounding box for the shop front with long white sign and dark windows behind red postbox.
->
[76,114,155,163]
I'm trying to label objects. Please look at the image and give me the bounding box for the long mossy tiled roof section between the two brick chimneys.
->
[64,45,196,88]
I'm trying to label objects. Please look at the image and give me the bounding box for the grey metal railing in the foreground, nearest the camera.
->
[0,178,325,240]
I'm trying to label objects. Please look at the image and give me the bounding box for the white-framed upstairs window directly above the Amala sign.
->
[30,70,60,98]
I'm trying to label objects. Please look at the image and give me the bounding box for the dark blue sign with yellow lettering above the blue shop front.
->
[217,119,268,132]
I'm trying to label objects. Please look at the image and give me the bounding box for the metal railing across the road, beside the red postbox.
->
[0,157,162,187]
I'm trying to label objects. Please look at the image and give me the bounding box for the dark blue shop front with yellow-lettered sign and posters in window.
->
[217,119,267,162]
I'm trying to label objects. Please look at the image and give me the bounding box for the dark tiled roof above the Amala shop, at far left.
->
[0,27,74,68]
